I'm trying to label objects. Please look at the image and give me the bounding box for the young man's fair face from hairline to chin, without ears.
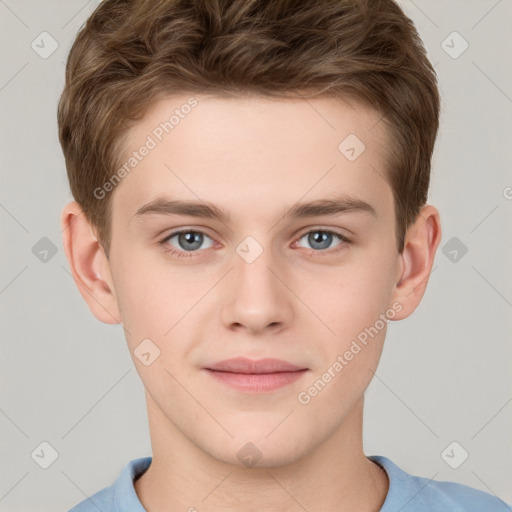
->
[103,96,400,466]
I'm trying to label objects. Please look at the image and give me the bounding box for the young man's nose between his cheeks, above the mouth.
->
[221,243,293,335]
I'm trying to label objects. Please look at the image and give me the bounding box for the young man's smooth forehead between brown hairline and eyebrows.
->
[113,95,391,226]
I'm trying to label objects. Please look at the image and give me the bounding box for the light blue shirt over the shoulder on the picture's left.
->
[68,457,152,512]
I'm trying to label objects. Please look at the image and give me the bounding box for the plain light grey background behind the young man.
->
[0,0,512,512]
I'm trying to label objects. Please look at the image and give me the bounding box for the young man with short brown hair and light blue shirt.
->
[58,0,510,512]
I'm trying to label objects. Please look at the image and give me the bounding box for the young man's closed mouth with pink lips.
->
[203,357,308,393]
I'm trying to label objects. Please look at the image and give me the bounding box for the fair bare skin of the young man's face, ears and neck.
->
[61,95,441,512]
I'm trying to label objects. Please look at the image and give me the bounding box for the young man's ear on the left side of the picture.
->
[61,201,121,324]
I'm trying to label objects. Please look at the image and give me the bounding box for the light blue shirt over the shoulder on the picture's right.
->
[368,455,512,512]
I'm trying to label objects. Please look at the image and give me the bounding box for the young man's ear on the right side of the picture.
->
[392,205,441,320]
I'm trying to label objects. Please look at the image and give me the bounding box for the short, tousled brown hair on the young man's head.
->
[58,0,440,258]
